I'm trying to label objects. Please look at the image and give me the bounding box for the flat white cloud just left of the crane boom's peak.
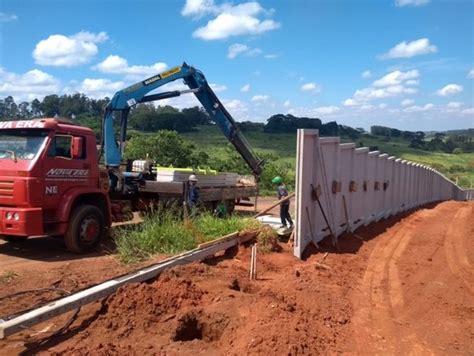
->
[93,55,168,79]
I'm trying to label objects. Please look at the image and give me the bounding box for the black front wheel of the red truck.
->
[64,205,105,253]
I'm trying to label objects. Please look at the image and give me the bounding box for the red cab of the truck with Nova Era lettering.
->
[0,119,110,252]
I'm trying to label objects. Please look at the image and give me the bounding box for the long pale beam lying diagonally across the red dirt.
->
[0,229,255,339]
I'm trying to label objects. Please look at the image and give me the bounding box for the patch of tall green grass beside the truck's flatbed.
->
[115,210,260,263]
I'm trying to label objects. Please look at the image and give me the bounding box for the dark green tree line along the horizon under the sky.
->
[0,93,361,139]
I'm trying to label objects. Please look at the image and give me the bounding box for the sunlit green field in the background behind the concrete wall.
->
[181,126,474,188]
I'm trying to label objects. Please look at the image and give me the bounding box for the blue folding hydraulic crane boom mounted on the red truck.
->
[102,63,263,176]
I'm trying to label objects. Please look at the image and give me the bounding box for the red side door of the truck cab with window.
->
[43,133,93,211]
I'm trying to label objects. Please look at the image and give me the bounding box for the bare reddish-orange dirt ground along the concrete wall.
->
[0,202,474,355]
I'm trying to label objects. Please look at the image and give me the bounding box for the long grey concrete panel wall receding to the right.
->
[294,130,474,257]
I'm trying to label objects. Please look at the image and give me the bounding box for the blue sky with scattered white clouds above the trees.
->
[0,0,474,130]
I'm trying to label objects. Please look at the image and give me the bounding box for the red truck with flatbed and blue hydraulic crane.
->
[0,63,263,253]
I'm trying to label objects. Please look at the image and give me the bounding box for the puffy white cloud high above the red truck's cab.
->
[33,31,108,67]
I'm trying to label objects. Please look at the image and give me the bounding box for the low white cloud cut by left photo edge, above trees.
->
[0,67,61,103]
